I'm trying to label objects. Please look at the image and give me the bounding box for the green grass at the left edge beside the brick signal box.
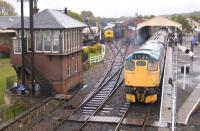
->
[0,58,17,106]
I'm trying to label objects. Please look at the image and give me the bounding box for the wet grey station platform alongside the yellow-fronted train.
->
[158,37,200,128]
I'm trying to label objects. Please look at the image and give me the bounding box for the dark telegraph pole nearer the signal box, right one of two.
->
[29,0,35,96]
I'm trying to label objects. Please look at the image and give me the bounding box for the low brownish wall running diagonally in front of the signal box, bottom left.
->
[0,98,62,131]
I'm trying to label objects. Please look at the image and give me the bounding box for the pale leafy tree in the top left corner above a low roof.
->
[0,0,17,16]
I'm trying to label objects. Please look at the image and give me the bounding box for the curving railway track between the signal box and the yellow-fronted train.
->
[54,40,129,130]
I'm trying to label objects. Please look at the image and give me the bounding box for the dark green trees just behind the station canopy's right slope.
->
[171,15,191,31]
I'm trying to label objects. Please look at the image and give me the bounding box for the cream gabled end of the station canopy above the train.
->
[137,16,182,30]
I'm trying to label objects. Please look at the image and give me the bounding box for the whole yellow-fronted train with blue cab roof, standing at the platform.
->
[124,30,167,103]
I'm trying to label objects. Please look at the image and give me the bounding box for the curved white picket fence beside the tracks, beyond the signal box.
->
[89,44,105,64]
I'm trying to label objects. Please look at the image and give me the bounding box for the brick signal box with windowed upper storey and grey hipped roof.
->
[10,9,86,94]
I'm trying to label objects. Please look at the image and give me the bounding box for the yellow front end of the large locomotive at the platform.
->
[124,60,160,103]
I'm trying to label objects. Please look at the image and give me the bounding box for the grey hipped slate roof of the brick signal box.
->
[9,9,86,29]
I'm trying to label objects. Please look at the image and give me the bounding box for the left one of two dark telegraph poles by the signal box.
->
[21,0,26,86]
